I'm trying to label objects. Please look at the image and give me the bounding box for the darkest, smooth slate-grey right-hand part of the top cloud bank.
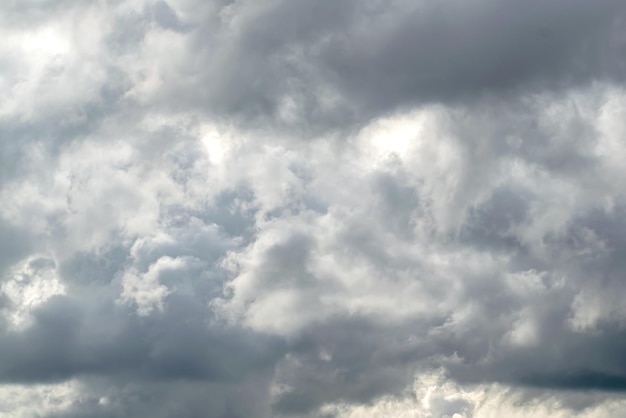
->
[322,1,623,111]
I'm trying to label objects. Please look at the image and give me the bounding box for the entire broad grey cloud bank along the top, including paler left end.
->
[125,0,624,130]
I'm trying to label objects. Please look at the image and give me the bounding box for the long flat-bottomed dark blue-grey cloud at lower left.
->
[0,296,284,383]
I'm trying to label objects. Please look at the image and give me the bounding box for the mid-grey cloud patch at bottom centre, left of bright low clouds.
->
[275,318,441,416]
